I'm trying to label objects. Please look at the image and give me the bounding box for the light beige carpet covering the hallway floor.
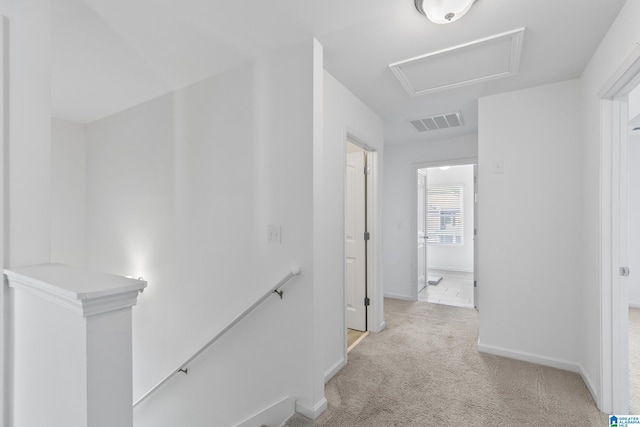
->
[315,299,608,427]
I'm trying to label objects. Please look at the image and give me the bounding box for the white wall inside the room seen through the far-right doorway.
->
[627,135,640,307]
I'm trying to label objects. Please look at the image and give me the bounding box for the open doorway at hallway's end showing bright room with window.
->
[415,161,477,308]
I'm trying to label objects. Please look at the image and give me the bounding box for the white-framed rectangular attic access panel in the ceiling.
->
[389,28,525,97]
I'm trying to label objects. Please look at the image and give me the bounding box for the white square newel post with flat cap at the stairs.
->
[5,264,147,427]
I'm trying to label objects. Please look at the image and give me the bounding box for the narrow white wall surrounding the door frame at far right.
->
[578,1,640,410]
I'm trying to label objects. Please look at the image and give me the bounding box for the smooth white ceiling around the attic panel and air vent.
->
[52,0,624,144]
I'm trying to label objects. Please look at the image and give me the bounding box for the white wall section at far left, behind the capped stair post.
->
[0,0,51,425]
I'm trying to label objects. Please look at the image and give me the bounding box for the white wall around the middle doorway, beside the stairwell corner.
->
[314,72,386,377]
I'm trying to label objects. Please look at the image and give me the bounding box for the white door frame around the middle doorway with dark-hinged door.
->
[342,129,385,361]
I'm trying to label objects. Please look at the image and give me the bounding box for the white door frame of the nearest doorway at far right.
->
[598,42,640,415]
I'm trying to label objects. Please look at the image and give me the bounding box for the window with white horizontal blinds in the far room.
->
[427,185,463,245]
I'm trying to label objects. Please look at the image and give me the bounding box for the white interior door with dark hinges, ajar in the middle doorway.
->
[345,151,367,331]
